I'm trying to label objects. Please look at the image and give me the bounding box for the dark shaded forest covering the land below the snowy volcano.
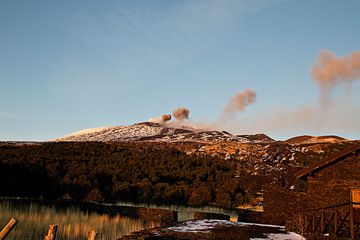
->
[0,142,248,207]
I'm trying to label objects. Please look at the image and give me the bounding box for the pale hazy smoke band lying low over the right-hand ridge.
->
[228,99,360,137]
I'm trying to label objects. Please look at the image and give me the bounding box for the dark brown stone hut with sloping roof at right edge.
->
[264,144,360,224]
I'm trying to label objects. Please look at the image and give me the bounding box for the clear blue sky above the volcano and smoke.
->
[0,0,360,141]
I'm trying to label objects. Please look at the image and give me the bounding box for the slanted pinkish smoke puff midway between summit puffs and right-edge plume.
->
[224,89,256,114]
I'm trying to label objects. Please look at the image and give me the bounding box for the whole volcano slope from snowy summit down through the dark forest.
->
[0,123,356,207]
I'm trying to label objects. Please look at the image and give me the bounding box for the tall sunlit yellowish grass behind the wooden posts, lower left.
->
[0,201,159,240]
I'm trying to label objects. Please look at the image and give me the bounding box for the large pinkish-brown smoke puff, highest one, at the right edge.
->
[312,50,360,87]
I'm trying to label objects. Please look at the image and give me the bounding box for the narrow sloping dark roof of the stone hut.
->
[295,144,360,178]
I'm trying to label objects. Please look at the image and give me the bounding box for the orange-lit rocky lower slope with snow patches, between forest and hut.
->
[169,140,360,182]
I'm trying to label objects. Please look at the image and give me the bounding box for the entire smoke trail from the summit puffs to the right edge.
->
[148,50,360,138]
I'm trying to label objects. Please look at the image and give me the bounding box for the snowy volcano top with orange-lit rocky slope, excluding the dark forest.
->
[55,122,356,186]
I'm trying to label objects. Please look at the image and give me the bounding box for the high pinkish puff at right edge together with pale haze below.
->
[231,50,360,135]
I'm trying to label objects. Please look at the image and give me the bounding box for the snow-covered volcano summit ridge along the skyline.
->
[51,122,348,145]
